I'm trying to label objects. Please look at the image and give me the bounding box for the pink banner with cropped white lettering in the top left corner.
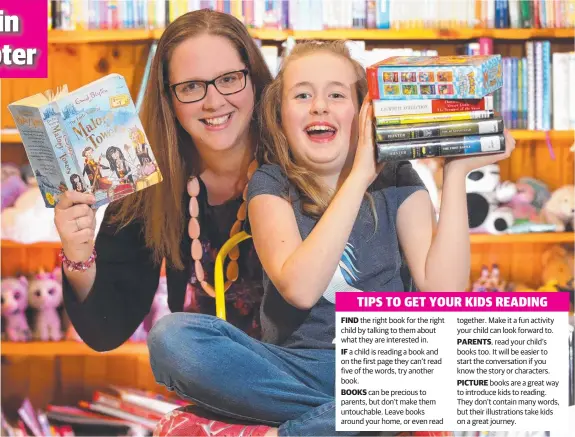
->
[0,0,48,79]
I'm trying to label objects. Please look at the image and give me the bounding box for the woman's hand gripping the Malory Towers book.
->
[54,191,96,262]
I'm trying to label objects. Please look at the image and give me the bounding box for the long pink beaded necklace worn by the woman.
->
[187,159,258,297]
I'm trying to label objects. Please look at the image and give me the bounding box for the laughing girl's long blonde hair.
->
[260,41,367,218]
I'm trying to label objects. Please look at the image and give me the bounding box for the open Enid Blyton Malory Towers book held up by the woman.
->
[8,74,162,208]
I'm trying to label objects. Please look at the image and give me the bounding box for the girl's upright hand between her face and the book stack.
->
[351,95,384,189]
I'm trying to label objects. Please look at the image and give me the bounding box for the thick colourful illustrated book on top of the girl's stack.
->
[367,55,503,100]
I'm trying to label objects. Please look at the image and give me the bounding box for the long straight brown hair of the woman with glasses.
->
[112,9,272,269]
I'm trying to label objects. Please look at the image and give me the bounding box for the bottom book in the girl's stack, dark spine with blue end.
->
[377,134,505,162]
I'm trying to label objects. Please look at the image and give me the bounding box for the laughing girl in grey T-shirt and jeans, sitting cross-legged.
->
[152,42,513,437]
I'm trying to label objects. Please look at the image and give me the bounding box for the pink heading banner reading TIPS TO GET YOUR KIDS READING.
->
[335,291,569,312]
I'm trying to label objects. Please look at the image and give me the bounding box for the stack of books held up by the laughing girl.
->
[367,55,505,162]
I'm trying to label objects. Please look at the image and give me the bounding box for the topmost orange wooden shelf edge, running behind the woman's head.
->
[48,28,575,44]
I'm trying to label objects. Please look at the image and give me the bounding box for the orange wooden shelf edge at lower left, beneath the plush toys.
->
[1,340,148,357]
